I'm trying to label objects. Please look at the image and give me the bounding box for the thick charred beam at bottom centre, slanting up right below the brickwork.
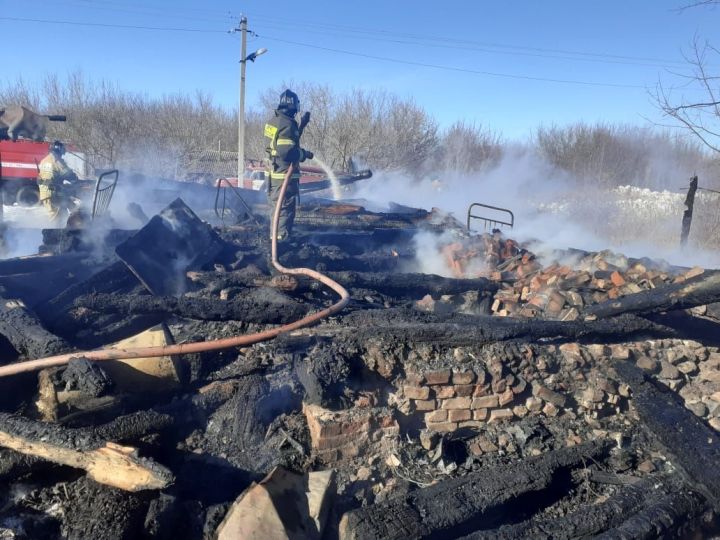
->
[340,441,610,540]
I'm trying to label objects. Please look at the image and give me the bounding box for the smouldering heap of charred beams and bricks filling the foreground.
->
[0,201,720,539]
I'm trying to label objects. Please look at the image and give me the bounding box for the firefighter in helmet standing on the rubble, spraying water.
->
[265,90,313,243]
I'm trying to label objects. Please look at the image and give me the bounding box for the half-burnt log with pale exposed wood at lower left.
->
[0,413,173,491]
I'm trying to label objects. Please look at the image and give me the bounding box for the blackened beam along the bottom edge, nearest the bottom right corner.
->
[463,475,706,540]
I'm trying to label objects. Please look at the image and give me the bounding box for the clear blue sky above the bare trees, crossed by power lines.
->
[0,0,720,139]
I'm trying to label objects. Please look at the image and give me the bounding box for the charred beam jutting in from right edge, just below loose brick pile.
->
[583,272,720,320]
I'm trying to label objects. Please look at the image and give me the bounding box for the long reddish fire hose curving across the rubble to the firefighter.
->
[0,165,350,377]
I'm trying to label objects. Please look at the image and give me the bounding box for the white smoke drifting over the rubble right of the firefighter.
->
[353,148,720,276]
